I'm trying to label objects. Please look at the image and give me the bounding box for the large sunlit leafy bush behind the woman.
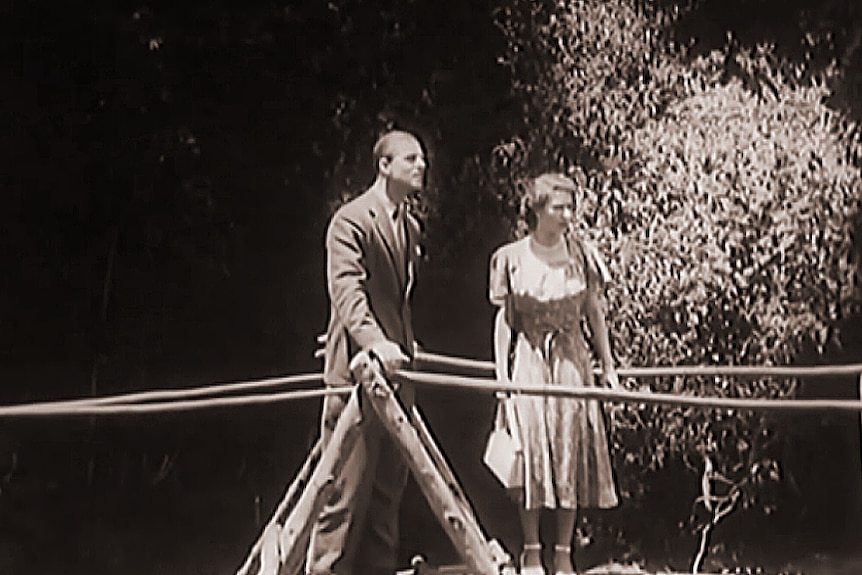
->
[496,0,862,568]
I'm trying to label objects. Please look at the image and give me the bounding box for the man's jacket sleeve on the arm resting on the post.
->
[326,208,387,349]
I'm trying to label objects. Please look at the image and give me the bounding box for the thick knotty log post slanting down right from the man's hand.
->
[354,354,505,575]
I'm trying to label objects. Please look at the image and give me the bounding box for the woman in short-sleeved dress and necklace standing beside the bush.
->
[490,174,619,575]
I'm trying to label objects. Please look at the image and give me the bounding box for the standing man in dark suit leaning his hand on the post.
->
[306,131,426,575]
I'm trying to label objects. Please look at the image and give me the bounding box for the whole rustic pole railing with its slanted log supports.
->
[0,344,862,575]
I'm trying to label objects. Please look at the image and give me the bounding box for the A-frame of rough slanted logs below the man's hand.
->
[237,353,515,575]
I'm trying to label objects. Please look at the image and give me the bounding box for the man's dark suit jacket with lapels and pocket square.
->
[324,190,420,385]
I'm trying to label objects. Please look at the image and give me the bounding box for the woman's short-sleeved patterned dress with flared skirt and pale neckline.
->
[489,236,618,509]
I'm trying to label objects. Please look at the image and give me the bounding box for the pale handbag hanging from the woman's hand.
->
[482,396,524,489]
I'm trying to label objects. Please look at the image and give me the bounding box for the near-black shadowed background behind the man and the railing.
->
[0,0,860,574]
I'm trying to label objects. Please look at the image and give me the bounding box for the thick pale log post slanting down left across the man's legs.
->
[237,387,362,575]
